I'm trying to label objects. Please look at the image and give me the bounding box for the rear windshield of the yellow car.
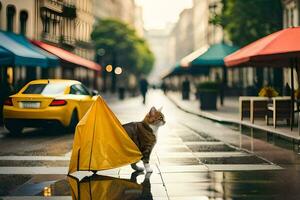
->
[23,83,67,95]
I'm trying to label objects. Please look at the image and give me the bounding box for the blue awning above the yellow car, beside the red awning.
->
[0,31,59,67]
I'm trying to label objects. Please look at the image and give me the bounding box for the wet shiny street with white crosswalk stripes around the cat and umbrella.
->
[0,91,300,200]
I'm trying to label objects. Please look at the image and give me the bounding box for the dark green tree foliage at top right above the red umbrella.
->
[211,0,282,46]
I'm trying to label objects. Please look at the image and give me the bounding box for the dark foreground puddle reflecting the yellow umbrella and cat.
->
[0,172,158,200]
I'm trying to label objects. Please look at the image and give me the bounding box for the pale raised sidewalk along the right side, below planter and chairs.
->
[167,92,300,143]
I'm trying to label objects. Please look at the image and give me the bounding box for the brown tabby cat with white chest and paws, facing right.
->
[123,107,166,173]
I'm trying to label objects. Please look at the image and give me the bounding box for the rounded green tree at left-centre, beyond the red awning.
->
[91,19,154,92]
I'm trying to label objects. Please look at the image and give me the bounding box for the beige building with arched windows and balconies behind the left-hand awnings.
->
[0,0,99,86]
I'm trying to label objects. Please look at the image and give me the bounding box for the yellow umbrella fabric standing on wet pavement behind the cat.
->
[69,96,142,174]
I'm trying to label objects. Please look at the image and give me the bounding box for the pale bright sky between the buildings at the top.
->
[135,0,193,30]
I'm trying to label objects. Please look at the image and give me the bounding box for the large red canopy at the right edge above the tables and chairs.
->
[224,27,300,67]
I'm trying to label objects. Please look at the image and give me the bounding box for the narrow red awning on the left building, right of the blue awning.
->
[31,40,101,71]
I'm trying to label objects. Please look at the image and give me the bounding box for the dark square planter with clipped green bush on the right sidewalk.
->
[197,81,219,110]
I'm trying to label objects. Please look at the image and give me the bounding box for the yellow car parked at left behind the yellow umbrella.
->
[3,79,97,134]
